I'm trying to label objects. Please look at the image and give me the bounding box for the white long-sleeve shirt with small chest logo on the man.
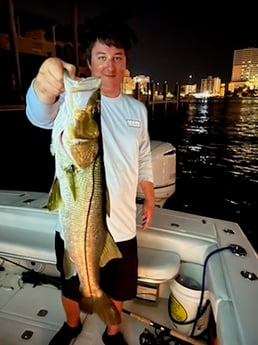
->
[26,83,153,242]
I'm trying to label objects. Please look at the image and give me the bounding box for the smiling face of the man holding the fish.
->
[89,41,126,90]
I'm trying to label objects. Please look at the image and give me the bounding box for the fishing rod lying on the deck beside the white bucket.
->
[122,309,207,345]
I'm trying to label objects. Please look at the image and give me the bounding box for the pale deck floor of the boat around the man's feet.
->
[0,271,175,345]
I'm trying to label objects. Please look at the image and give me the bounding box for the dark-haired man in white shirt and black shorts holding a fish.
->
[26,21,154,345]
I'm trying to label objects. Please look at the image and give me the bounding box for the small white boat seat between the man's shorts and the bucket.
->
[138,247,180,284]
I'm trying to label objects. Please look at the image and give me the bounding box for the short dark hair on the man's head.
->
[80,15,137,62]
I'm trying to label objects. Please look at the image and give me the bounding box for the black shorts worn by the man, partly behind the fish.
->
[55,232,138,301]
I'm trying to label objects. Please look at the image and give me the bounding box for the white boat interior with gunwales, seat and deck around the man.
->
[0,190,258,345]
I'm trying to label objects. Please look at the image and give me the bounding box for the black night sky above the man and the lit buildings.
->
[10,0,258,89]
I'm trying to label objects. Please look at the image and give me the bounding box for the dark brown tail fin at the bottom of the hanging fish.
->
[79,292,121,325]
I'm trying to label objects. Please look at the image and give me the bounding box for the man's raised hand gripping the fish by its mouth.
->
[34,57,76,104]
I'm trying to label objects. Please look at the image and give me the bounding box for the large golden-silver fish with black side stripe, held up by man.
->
[48,73,121,324]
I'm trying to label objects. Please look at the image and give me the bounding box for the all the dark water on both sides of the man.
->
[0,98,258,251]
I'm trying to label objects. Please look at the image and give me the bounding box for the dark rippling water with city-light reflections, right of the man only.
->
[150,98,258,251]
